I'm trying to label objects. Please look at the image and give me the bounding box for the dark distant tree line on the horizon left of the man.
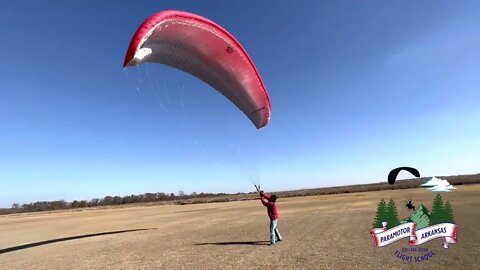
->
[0,190,232,214]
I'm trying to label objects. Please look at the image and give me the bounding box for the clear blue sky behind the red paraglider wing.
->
[0,0,480,207]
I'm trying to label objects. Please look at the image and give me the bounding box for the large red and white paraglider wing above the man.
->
[124,11,271,128]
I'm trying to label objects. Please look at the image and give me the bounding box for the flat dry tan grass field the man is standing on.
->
[0,185,480,270]
